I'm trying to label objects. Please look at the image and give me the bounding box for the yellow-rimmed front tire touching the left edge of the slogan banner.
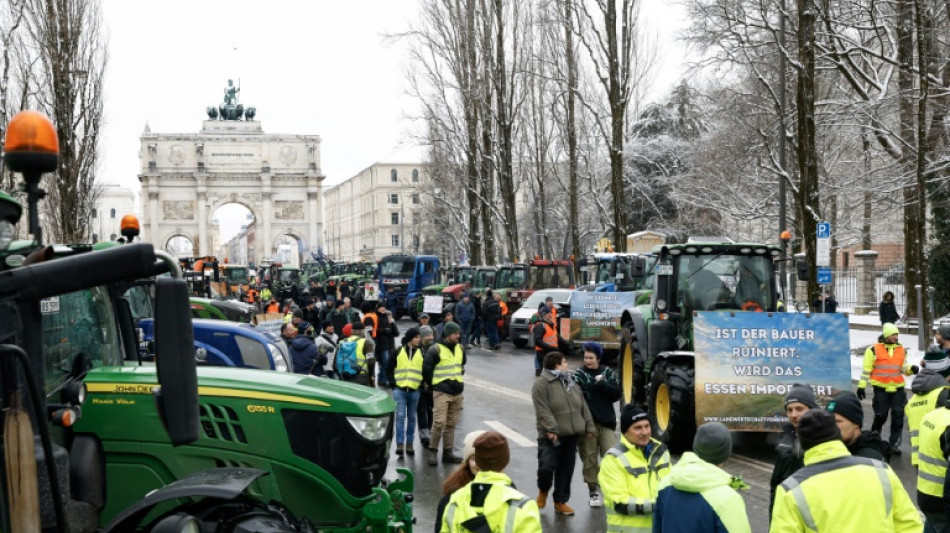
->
[648,361,696,453]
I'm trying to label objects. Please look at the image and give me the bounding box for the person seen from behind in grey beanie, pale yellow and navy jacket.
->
[653,422,752,533]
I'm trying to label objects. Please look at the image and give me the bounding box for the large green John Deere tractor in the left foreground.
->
[0,110,412,533]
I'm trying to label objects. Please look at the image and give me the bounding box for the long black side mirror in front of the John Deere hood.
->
[153,278,198,446]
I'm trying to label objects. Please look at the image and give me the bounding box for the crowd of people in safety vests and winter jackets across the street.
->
[242,276,950,533]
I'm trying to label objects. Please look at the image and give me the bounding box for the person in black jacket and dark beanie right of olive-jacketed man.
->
[572,342,620,507]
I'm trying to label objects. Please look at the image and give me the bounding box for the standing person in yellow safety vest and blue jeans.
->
[386,328,423,457]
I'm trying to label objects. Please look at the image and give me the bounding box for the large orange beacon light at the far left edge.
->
[3,111,59,175]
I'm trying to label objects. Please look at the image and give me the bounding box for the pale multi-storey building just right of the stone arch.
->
[324,162,431,261]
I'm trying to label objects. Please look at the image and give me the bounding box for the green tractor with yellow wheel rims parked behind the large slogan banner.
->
[617,239,807,451]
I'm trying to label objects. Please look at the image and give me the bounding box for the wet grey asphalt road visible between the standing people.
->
[389,321,916,533]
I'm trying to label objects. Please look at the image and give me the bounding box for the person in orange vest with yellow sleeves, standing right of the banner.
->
[857,323,919,454]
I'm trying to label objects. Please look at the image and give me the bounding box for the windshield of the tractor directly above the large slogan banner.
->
[677,254,774,311]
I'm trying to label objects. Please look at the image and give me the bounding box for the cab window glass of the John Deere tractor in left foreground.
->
[40,287,123,392]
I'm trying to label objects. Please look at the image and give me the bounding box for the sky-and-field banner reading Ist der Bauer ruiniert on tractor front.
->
[693,312,851,431]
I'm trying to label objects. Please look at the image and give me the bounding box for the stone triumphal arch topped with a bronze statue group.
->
[139,86,324,261]
